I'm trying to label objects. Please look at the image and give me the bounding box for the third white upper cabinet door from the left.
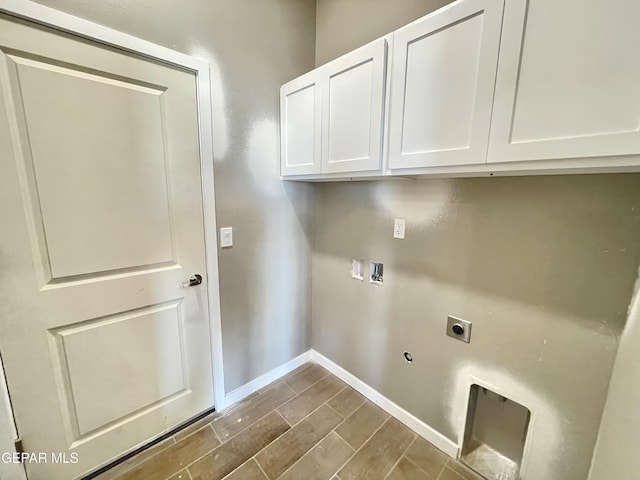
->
[389,0,504,169]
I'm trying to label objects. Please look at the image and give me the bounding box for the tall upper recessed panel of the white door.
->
[12,55,173,279]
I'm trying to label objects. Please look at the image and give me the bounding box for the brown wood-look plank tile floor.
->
[98,363,479,480]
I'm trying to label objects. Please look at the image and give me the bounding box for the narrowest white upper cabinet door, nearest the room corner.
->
[280,70,322,176]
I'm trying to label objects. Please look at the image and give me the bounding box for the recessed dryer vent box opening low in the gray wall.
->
[461,385,531,480]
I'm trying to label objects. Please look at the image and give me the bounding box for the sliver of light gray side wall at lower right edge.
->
[589,270,640,480]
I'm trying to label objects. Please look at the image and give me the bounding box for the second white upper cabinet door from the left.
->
[321,38,387,173]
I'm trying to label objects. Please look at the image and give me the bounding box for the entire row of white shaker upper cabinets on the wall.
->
[281,0,640,180]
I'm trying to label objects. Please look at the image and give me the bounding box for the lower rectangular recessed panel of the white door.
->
[49,302,188,438]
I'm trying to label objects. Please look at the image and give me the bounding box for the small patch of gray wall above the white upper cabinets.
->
[316,0,451,66]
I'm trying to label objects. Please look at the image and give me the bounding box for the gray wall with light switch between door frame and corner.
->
[31,0,315,391]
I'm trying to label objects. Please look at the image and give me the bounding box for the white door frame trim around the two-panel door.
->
[0,0,226,468]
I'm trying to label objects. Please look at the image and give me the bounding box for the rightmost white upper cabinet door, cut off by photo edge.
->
[489,0,640,162]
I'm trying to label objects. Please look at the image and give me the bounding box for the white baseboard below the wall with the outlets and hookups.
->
[310,350,458,458]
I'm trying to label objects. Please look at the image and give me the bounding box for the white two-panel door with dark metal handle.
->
[0,15,213,480]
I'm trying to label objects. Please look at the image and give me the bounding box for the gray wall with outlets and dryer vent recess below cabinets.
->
[312,174,640,480]
